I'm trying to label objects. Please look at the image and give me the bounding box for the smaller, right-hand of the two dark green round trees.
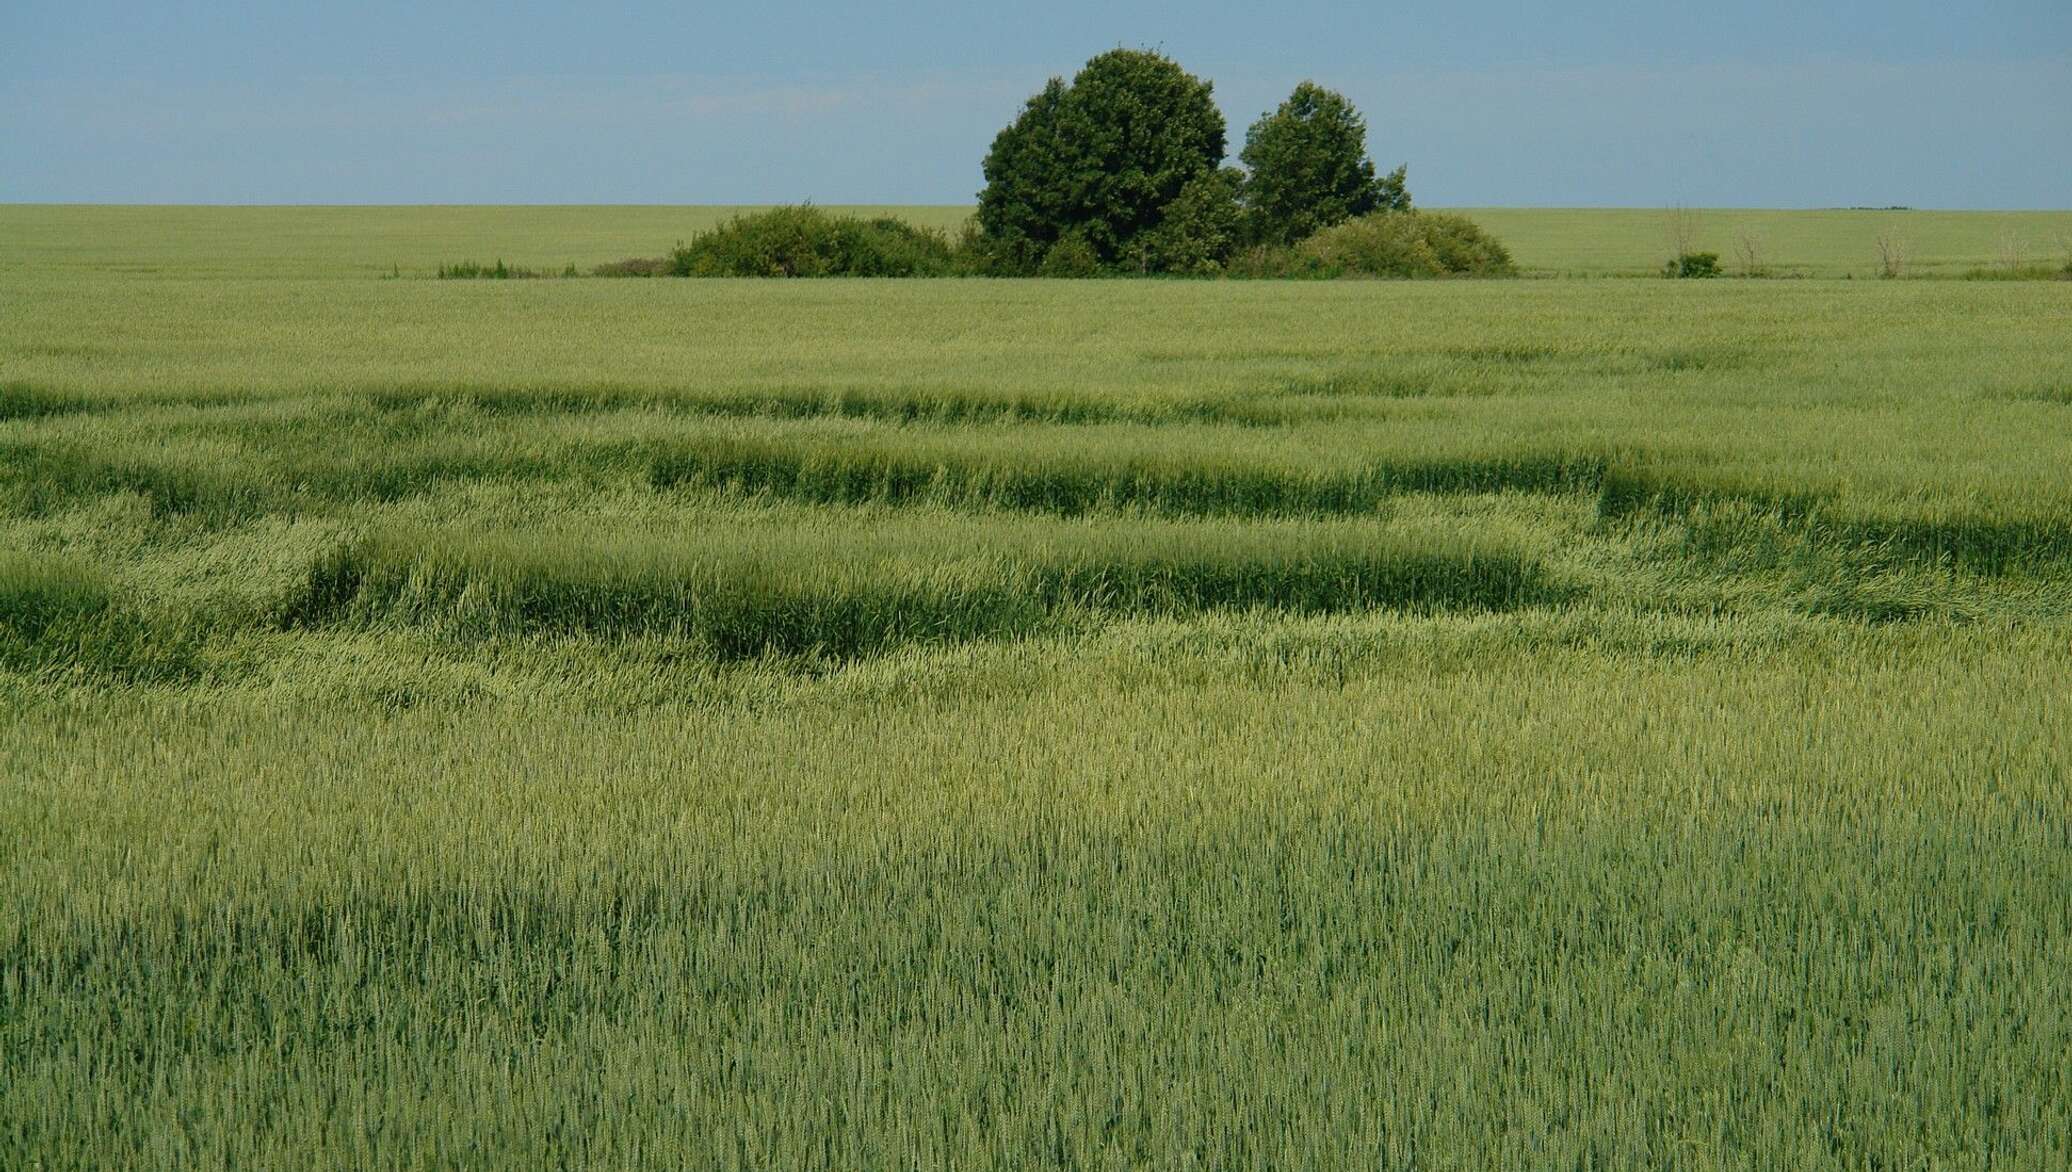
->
[1239,81,1411,244]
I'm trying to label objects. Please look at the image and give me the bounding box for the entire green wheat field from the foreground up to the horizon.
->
[0,207,2072,1170]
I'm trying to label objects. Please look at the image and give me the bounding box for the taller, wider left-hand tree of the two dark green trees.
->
[978,50,1227,271]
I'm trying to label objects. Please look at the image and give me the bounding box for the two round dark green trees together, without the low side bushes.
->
[970,50,1411,275]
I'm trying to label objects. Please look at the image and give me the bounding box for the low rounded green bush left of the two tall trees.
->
[669,205,953,277]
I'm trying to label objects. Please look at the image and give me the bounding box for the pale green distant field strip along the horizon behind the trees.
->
[0,205,2072,277]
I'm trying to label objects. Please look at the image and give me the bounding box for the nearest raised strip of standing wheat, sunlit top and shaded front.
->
[280,516,1556,658]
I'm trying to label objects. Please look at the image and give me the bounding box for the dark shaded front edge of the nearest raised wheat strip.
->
[276,538,1571,661]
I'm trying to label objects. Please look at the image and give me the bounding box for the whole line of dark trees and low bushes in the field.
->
[439,48,1515,277]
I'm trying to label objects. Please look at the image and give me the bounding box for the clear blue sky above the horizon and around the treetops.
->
[0,0,2072,207]
